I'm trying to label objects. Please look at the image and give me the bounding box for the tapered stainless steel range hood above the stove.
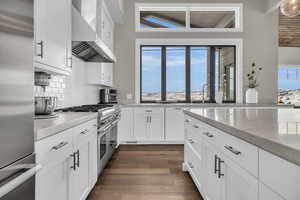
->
[72,7,116,63]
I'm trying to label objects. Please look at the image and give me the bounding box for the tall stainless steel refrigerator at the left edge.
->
[0,0,40,200]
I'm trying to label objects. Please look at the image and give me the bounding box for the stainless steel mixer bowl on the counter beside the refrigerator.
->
[34,97,57,115]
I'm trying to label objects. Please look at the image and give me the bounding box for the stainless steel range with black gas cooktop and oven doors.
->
[57,104,121,174]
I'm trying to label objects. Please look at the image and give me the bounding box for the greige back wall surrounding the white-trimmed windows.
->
[114,0,278,103]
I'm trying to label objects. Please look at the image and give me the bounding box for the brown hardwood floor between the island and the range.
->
[88,145,202,200]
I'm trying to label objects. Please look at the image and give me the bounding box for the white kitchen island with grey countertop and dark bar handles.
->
[183,107,300,200]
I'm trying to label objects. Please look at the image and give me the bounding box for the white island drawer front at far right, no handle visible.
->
[259,150,300,200]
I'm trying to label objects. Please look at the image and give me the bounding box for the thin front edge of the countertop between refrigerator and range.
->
[34,113,98,142]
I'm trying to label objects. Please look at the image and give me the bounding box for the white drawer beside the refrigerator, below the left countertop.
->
[35,129,73,165]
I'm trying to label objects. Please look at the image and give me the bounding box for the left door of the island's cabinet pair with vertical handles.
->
[203,142,222,200]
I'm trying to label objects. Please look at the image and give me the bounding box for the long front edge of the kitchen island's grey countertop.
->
[183,110,300,166]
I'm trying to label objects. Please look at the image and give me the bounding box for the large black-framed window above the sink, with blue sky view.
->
[140,46,236,103]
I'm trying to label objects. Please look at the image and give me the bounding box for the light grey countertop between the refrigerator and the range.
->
[34,112,98,141]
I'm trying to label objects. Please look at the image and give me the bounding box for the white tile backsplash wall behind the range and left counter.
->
[34,57,99,108]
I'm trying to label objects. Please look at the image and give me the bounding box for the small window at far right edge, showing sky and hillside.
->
[278,66,300,104]
